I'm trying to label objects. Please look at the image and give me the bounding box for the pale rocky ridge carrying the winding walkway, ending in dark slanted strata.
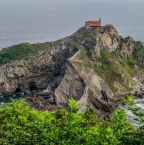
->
[69,50,114,116]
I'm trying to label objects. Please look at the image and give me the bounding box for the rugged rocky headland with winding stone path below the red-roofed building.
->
[0,27,144,115]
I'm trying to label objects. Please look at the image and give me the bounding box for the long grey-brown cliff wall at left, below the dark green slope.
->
[0,44,75,95]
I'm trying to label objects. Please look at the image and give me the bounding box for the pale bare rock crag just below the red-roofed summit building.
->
[83,27,120,59]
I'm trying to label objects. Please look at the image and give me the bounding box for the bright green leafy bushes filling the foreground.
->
[0,99,144,145]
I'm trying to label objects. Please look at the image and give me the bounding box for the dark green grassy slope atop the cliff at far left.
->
[0,43,52,65]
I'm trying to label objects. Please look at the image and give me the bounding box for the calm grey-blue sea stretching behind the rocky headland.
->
[0,0,144,48]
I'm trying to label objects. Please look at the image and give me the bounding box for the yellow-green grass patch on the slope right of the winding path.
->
[81,50,136,92]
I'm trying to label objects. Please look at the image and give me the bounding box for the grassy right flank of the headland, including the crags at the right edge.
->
[77,32,144,93]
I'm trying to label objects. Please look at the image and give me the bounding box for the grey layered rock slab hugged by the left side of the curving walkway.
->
[54,64,86,106]
